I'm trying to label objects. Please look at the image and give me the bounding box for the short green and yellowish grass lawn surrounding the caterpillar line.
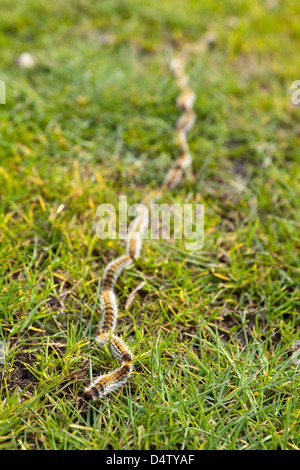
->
[0,0,300,450]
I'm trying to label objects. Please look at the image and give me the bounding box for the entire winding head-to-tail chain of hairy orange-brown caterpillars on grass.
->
[83,41,209,401]
